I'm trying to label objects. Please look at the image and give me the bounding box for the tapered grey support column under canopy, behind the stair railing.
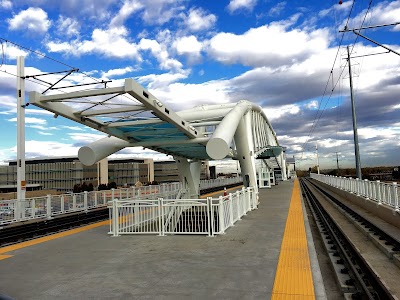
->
[174,157,201,199]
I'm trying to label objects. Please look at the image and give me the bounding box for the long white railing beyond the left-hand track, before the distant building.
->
[0,182,182,225]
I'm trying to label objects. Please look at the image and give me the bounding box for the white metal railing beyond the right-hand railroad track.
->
[311,173,400,211]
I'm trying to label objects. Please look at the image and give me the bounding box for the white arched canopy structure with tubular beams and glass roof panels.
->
[29,79,286,196]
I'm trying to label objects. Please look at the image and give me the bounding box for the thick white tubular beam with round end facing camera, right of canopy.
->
[206,101,251,159]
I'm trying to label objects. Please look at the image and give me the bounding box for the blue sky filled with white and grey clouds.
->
[0,0,400,168]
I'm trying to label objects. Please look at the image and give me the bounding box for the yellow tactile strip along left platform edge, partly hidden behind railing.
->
[0,187,242,260]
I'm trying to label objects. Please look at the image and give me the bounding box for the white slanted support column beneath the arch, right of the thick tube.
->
[234,113,258,193]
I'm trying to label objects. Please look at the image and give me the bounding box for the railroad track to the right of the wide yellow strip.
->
[300,179,400,299]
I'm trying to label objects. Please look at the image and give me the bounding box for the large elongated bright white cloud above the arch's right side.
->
[207,23,329,67]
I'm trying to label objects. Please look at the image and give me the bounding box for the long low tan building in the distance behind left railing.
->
[0,157,210,192]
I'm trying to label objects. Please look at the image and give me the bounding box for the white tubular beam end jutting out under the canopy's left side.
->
[78,137,130,166]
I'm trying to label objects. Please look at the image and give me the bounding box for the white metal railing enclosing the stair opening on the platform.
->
[109,187,258,236]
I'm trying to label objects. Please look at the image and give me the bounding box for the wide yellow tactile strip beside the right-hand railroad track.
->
[271,179,315,300]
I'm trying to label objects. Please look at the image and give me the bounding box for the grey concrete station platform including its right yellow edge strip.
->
[0,180,326,300]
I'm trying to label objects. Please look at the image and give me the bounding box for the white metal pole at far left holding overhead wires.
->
[17,56,26,217]
